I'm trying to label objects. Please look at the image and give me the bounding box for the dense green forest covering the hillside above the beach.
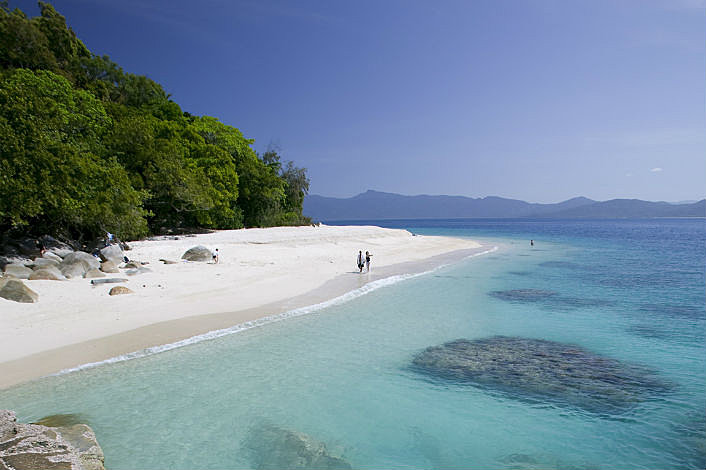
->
[0,1,310,239]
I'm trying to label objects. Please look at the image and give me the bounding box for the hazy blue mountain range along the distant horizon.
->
[303,190,706,221]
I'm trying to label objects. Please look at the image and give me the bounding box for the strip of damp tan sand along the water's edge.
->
[0,229,490,389]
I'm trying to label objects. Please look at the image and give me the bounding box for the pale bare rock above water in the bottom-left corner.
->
[0,410,105,470]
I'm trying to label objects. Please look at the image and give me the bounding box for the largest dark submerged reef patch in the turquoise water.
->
[412,336,669,413]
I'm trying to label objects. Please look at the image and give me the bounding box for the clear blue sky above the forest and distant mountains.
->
[10,0,706,202]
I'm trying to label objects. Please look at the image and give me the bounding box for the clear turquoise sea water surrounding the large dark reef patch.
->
[0,220,706,470]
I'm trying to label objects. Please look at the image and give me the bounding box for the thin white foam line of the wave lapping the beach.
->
[49,246,498,376]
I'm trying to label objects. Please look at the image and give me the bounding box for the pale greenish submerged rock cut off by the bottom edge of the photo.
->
[242,424,352,470]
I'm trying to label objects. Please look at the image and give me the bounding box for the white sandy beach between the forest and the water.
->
[0,226,484,388]
